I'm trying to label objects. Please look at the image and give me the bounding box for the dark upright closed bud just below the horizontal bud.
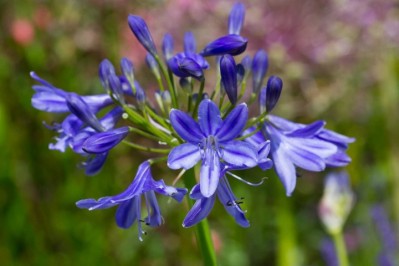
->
[220,55,237,105]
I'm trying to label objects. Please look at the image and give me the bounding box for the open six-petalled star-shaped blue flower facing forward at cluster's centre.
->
[168,99,257,197]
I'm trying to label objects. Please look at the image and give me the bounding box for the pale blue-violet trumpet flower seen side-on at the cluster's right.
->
[246,115,354,196]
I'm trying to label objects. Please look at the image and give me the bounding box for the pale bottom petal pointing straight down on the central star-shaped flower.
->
[200,150,220,198]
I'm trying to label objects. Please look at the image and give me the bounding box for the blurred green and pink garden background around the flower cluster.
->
[0,0,399,265]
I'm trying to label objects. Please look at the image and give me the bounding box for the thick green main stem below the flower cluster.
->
[183,167,217,266]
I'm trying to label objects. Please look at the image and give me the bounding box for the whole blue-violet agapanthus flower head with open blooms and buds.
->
[31,3,353,239]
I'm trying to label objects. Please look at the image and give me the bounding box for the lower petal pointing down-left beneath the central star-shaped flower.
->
[183,197,215,227]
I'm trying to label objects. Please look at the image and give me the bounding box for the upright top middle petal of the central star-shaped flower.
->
[198,99,223,136]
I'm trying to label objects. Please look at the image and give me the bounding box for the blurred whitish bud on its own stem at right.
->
[319,172,355,235]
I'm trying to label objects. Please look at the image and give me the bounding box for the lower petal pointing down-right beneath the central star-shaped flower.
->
[217,178,249,227]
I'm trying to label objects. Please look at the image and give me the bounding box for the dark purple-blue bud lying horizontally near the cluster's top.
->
[200,34,248,56]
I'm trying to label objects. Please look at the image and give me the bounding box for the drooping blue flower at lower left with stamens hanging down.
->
[76,161,187,240]
